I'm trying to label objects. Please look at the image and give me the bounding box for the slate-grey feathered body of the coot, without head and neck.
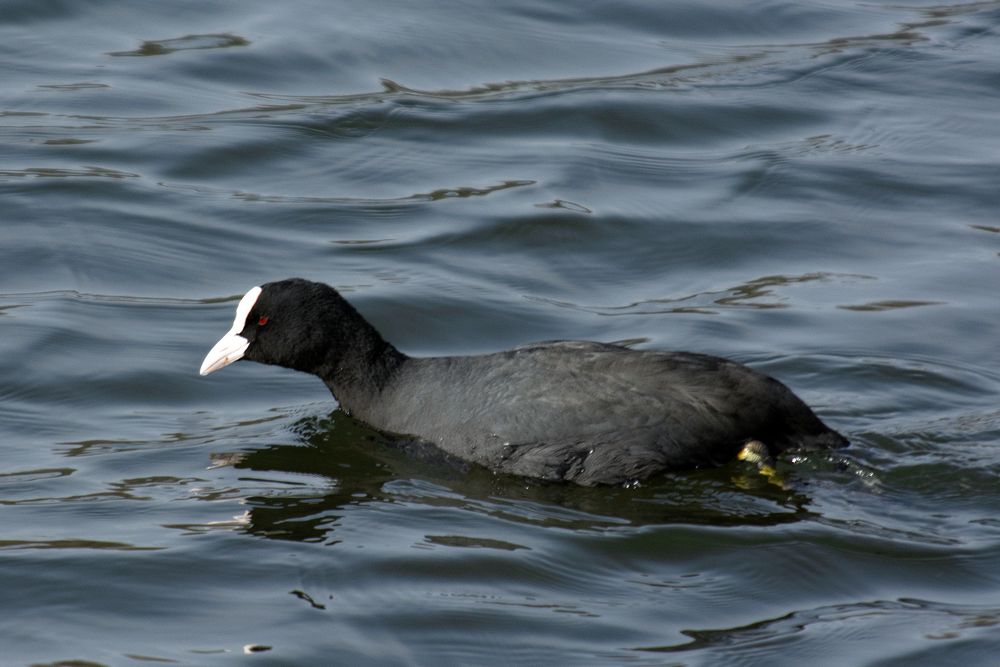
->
[346,341,846,484]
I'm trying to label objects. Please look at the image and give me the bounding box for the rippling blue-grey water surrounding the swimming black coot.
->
[0,0,1000,665]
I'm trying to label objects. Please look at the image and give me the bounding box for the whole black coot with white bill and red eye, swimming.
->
[201,278,847,485]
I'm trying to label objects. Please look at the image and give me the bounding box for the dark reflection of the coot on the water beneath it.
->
[221,410,843,543]
